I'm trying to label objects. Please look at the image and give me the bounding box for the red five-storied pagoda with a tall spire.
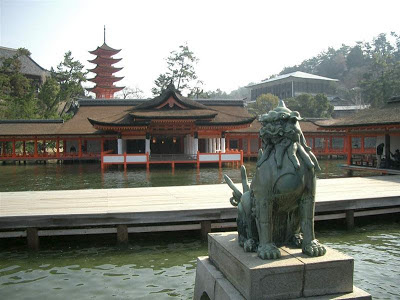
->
[87,26,124,99]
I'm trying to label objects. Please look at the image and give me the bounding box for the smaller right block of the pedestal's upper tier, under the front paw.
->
[282,247,354,297]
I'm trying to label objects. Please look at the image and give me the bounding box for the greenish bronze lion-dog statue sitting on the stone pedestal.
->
[224,100,326,259]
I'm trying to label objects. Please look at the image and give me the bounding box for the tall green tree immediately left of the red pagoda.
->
[51,51,88,116]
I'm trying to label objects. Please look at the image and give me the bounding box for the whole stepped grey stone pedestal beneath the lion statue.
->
[194,232,371,299]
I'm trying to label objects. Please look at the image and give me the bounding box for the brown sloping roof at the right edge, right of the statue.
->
[315,98,400,128]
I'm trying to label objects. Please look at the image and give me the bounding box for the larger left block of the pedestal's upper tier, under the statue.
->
[208,232,304,299]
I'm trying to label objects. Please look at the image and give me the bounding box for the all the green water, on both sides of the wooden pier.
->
[0,160,400,300]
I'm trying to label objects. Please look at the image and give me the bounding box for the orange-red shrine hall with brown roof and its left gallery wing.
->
[0,85,259,167]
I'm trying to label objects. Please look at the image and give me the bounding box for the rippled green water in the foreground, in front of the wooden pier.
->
[0,219,400,300]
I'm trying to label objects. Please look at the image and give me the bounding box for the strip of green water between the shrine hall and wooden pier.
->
[0,160,382,192]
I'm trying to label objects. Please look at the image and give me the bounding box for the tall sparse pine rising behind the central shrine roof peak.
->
[151,43,199,95]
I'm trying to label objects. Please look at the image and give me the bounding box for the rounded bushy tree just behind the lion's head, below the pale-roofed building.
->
[285,94,333,118]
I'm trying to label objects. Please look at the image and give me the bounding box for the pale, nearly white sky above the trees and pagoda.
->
[0,0,400,97]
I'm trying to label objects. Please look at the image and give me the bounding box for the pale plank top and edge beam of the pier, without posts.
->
[0,176,400,229]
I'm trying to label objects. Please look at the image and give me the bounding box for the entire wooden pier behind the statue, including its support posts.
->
[0,176,400,248]
